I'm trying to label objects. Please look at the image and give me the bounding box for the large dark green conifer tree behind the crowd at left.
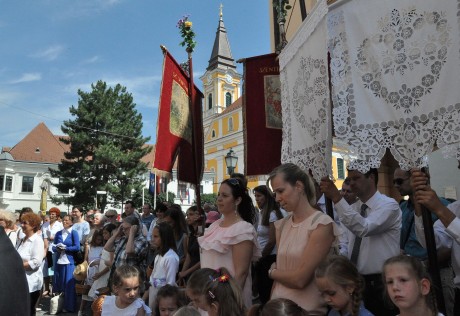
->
[50,81,151,210]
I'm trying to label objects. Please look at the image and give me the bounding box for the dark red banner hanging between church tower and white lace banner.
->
[243,54,283,176]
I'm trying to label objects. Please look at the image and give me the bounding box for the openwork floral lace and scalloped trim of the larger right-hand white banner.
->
[327,0,460,172]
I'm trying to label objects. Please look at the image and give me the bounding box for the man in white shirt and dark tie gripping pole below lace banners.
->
[320,169,401,316]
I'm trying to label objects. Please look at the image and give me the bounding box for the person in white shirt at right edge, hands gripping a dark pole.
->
[411,165,460,315]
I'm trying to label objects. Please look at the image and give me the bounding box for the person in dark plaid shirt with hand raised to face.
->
[104,215,149,283]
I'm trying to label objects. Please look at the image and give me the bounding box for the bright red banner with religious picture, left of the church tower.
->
[153,50,204,184]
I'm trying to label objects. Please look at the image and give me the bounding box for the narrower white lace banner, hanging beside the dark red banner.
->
[279,0,332,182]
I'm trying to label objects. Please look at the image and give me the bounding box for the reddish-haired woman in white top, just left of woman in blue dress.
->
[42,207,64,296]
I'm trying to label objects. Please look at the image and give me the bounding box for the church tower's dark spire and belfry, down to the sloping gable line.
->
[200,5,242,123]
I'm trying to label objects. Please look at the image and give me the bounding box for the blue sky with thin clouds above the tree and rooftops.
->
[0,0,271,147]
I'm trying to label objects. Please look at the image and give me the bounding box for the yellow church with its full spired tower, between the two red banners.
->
[200,5,244,193]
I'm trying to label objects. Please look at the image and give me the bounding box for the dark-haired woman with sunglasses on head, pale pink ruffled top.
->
[198,178,261,308]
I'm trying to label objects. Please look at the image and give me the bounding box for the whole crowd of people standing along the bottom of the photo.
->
[0,163,460,316]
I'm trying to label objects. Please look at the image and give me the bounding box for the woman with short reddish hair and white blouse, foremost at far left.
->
[15,213,45,315]
